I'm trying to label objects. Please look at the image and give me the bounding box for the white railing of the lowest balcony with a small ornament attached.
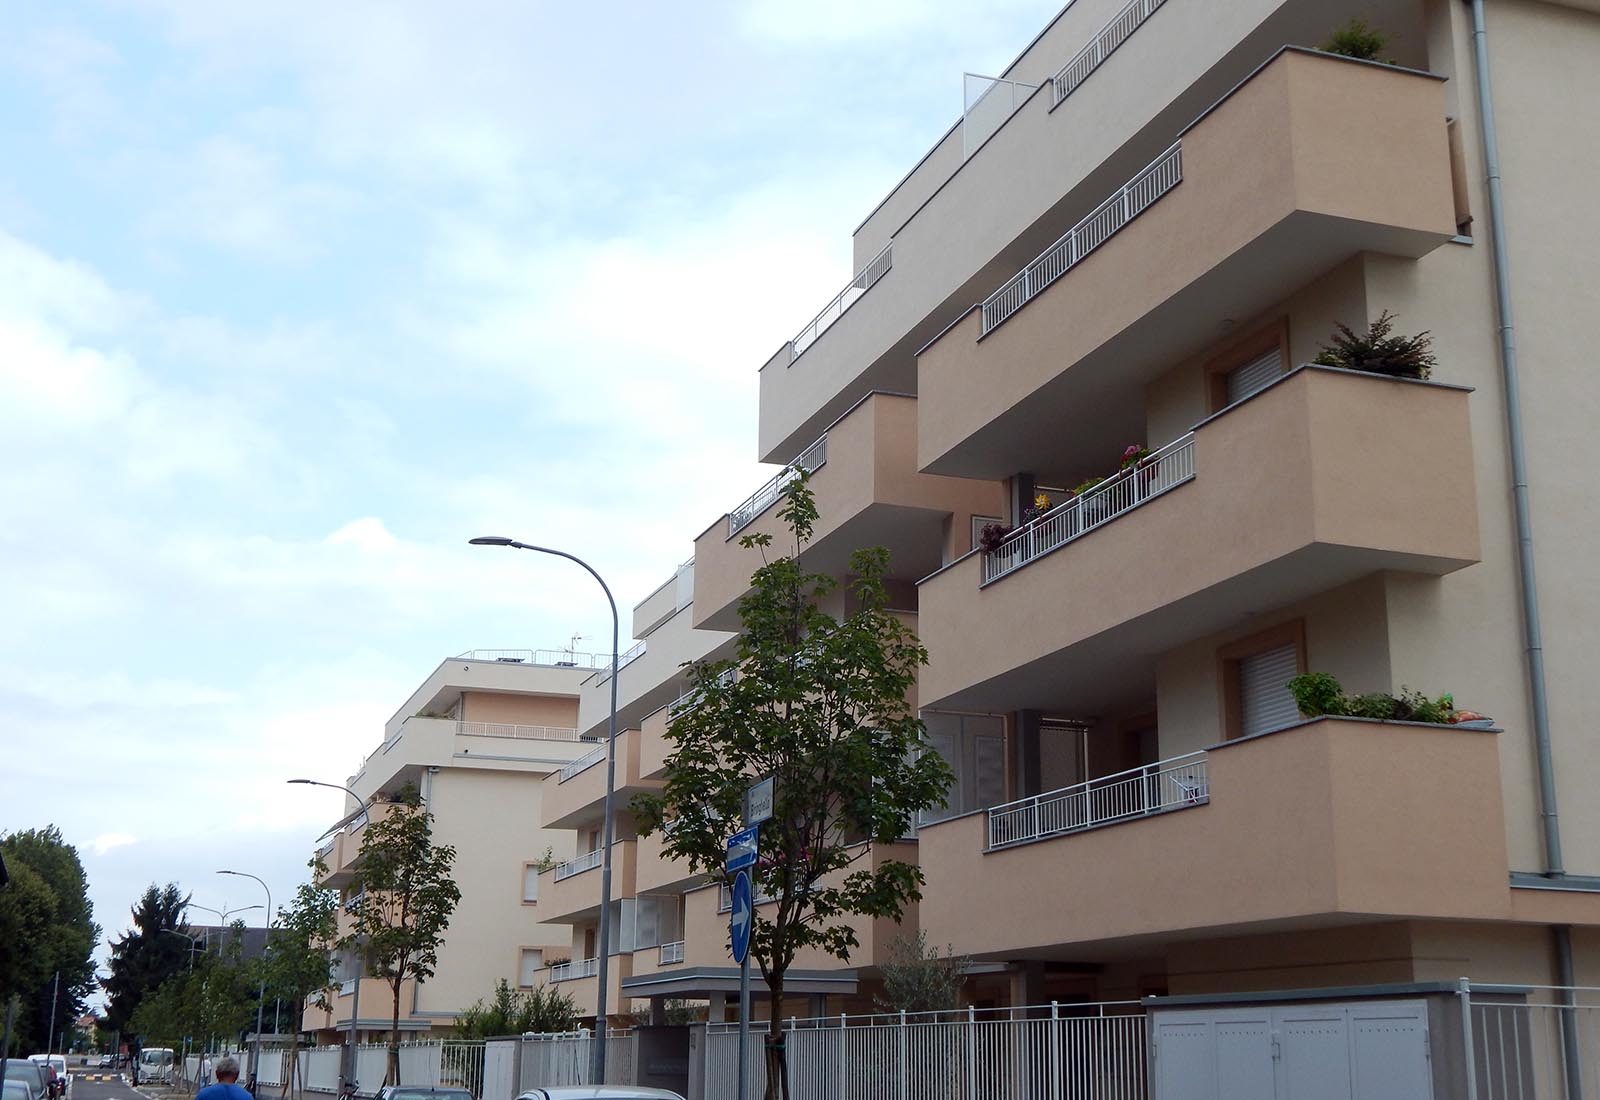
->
[989,753,1211,849]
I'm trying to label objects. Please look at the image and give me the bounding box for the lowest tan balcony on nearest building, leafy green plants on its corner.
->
[918,718,1510,958]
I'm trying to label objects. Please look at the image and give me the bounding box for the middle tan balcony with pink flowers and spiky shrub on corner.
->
[918,366,1478,711]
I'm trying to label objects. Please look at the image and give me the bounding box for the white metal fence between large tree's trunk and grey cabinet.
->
[706,1002,1147,1100]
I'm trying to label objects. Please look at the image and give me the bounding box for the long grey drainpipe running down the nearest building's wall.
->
[1469,0,1566,878]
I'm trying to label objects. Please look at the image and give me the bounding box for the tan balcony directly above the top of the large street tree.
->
[694,393,1003,630]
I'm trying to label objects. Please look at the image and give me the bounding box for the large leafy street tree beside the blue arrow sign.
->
[634,470,954,1098]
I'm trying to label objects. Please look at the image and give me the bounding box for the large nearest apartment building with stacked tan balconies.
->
[531,0,1600,1042]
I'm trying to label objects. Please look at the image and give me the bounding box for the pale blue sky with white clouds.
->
[0,0,1061,997]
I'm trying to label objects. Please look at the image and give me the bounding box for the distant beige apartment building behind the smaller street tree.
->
[302,649,610,1042]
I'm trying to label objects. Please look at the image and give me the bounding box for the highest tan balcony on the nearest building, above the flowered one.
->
[917,47,1456,478]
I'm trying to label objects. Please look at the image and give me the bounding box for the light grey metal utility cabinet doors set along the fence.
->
[1150,1001,1434,1100]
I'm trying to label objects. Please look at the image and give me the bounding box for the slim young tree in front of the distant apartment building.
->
[339,785,461,1084]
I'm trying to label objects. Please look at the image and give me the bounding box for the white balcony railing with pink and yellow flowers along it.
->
[982,433,1195,584]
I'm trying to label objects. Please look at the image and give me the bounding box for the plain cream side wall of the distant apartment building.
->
[418,767,573,1014]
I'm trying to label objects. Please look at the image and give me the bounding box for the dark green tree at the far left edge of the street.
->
[0,825,99,1050]
